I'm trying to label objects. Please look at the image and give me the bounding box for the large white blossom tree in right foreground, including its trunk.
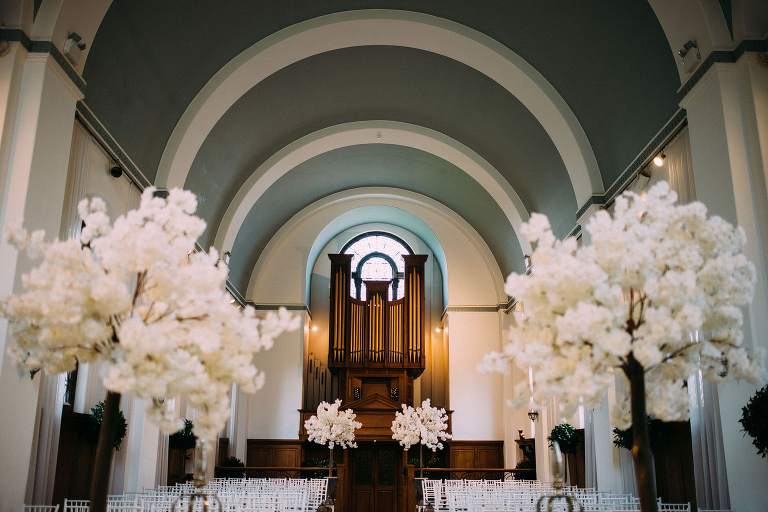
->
[484,182,764,511]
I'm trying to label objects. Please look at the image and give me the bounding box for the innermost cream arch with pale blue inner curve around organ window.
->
[246,187,506,305]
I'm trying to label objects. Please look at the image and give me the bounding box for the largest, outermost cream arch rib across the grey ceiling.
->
[156,9,603,205]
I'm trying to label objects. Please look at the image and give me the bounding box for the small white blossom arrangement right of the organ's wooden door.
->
[392,399,451,451]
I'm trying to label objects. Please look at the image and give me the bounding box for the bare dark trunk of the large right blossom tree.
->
[626,355,658,512]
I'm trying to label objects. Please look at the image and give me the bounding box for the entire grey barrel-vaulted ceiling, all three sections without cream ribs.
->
[84,0,679,290]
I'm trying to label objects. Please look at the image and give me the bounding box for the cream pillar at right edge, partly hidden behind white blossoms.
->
[682,53,768,512]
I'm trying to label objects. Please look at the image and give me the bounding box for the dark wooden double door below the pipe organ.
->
[349,443,402,512]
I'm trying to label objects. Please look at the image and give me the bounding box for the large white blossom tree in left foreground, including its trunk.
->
[2,188,299,510]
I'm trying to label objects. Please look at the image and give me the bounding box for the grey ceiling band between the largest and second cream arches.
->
[186,46,576,245]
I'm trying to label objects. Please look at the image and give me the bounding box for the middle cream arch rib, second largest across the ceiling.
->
[214,120,531,254]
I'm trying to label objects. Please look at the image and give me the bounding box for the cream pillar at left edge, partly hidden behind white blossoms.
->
[0,47,81,512]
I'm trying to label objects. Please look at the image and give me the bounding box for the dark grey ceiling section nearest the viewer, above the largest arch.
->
[85,0,679,190]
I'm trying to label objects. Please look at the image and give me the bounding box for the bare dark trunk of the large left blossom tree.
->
[90,391,120,512]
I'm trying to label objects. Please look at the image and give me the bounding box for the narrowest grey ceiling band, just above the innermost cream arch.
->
[230,144,524,290]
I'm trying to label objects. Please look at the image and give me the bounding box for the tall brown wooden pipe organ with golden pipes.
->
[328,254,427,404]
